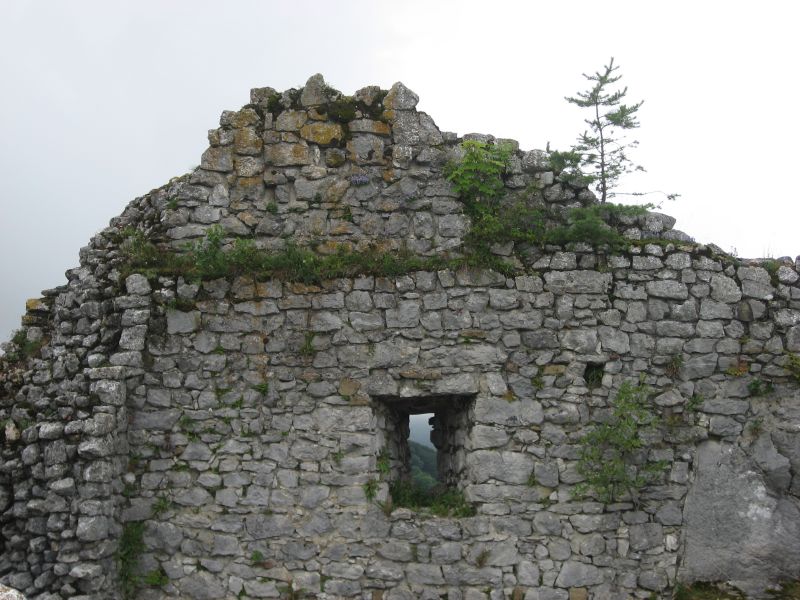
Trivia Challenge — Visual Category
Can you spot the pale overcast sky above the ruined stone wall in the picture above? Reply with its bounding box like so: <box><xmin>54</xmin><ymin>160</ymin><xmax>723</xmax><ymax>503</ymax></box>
<box><xmin>0</xmin><ymin>0</ymin><xmax>800</xmax><ymax>340</ymax></box>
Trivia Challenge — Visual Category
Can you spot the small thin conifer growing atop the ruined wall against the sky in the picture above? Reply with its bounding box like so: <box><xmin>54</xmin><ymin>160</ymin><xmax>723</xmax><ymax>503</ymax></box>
<box><xmin>559</xmin><ymin>57</ymin><xmax>644</xmax><ymax>202</ymax></box>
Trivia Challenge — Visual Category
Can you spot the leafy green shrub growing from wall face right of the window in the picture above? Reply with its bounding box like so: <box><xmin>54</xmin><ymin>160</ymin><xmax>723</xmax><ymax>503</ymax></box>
<box><xmin>574</xmin><ymin>381</ymin><xmax>666</xmax><ymax>504</ymax></box>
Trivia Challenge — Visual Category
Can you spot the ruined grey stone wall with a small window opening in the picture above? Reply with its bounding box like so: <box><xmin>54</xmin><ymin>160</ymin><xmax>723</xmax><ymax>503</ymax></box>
<box><xmin>0</xmin><ymin>75</ymin><xmax>800</xmax><ymax>600</ymax></box>
